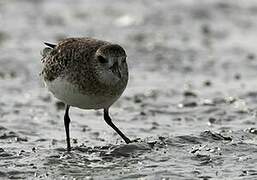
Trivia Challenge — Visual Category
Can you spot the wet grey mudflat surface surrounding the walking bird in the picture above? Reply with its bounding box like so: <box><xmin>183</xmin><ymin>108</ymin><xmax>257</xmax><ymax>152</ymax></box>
<box><xmin>0</xmin><ymin>0</ymin><xmax>257</xmax><ymax>180</ymax></box>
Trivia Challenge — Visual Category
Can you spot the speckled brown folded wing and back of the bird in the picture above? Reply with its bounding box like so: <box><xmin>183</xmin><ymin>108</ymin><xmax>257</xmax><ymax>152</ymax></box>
<box><xmin>42</xmin><ymin>38</ymin><xmax>108</xmax><ymax>81</ymax></box>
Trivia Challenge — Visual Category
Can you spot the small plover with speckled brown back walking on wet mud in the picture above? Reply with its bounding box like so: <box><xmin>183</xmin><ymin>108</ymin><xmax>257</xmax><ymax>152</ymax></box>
<box><xmin>41</xmin><ymin>38</ymin><xmax>131</xmax><ymax>151</ymax></box>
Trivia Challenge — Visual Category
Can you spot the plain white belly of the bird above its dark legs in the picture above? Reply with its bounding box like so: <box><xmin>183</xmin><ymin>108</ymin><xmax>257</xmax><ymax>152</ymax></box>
<box><xmin>45</xmin><ymin>78</ymin><xmax>119</xmax><ymax>109</ymax></box>
